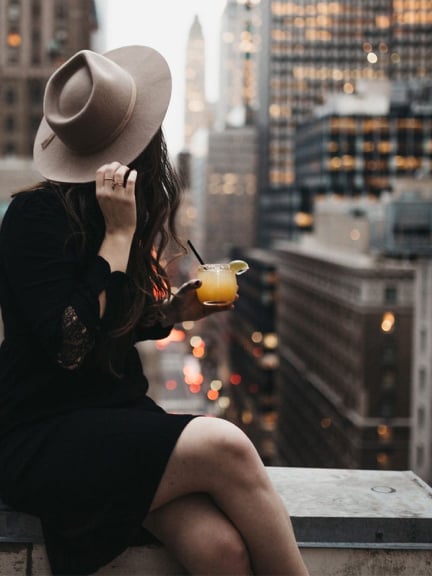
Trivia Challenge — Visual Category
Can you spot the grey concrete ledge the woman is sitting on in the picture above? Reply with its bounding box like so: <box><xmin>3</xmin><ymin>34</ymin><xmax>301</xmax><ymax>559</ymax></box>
<box><xmin>0</xmin><ymin>467</ymin><xmax>432</xmax><ymax>576</ymax></box>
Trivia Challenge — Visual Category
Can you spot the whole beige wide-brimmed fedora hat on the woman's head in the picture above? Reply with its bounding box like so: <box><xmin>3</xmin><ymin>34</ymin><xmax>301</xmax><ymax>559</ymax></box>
<box><xmin>33</xmin><ymin>46</ymin><xmax>171</xmax><ymax>182</ymax></box>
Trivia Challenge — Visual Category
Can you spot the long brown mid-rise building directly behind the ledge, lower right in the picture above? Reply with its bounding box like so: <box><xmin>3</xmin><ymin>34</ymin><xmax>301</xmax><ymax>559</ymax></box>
<box><xmin>276</xmin><ymin>244</ymin><xmax>414</xmax><ymax>470</ymax></box>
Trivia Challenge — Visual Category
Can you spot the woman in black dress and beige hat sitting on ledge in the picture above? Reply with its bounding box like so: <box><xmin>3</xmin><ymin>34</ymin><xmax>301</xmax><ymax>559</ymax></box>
<box><xmin>0</xmin><ymin>46</ymin><xmax>307</xmax><ymax>575</ymax></box>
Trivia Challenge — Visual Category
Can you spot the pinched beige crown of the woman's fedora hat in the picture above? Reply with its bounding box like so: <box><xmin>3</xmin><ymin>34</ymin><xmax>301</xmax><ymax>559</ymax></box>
<box><xmin>44</xmin><ymin>50</ymin><xmax>136</xmax><ymax>154</ymax></box>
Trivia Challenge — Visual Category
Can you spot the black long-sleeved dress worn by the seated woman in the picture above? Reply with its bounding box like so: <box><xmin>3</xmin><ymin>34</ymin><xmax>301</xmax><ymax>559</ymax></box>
<box><xmin>0</xmin><ymin>188</ymin><xmax>193</xmax><ymax>574</ymax></box>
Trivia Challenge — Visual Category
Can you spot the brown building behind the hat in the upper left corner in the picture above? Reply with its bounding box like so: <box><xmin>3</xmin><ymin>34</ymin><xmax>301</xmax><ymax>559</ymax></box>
<box><xmin>0</xmin><ymin>0</ymin><xmax>96</xmax><ymax>158</ymax></box>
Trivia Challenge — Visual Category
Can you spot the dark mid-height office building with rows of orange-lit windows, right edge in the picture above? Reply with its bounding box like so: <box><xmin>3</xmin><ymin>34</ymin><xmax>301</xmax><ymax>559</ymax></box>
<box><xmin>295</xmin><ymin>79</ymin><xmax>432</xmax><ymax>207</ymax></box>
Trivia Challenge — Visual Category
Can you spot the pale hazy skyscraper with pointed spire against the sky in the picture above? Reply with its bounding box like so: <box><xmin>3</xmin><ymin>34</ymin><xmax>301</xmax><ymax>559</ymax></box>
<box><xmin>184</xmin><ymin>15</ymin><xmax>208</xmax><ymax>148</ymax></box>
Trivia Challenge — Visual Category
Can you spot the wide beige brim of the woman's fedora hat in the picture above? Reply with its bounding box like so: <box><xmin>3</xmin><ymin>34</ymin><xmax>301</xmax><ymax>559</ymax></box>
<box><xmin>33</xmin><ymin>46</ymin><xmax>172</xmax><ymax>183</ymax></box>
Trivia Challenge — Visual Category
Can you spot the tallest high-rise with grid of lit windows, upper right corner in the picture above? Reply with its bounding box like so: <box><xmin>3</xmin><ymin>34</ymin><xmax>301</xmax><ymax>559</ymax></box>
<box><xmin>255</xmin><ymin>0</ymin><xmax>432</xmax><ymax>246</ymax></box>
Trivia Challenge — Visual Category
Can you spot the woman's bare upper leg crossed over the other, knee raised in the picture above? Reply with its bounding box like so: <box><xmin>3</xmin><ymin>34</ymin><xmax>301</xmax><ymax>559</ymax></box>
<box><xmin>152</xmin><ymin>417</ymin><xmax>308</xmax><ymax>576</ymax></box>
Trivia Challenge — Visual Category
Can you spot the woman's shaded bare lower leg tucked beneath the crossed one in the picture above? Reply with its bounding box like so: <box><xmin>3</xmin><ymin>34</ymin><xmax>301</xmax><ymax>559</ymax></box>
<box><xmin>144</xmin><ymin>494</ymin><xmax>252</xmax><ymax>576</ymax></box>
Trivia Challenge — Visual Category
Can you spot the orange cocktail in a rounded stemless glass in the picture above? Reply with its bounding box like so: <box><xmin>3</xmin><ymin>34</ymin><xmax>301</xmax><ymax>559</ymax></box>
<box><xmin>197</xmin><ymin>264</ymin><xmax>237</xmax><ymax>306</ymax></box>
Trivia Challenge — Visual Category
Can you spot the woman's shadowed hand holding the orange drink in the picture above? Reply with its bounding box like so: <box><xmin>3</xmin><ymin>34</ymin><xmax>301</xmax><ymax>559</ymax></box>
<box><xmin>162</xmin><ymin>280</ymin><xmax>234</xmax><ymax>326</ymax></box>
